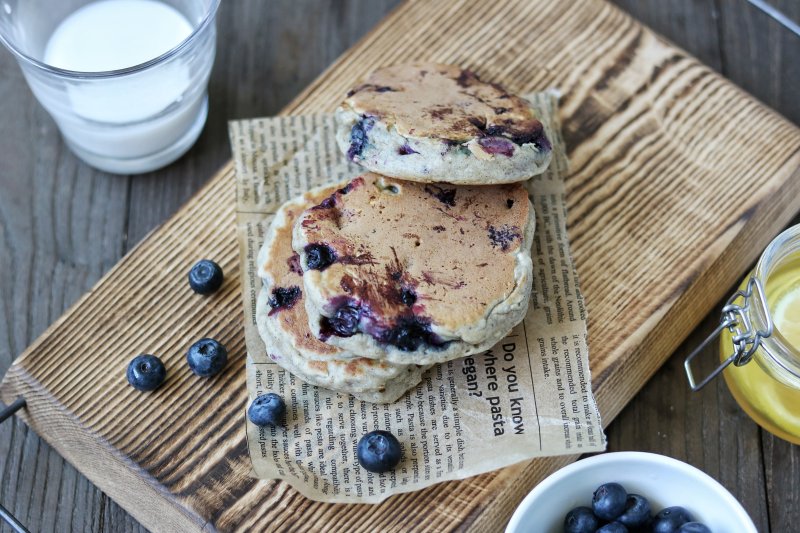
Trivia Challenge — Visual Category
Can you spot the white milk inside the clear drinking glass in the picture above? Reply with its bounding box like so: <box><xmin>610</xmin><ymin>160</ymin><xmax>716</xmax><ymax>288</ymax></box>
<box><xmin>32</xmin><ymin>0</ymin><xmax>213</xmax><ymax>173</ymax></box>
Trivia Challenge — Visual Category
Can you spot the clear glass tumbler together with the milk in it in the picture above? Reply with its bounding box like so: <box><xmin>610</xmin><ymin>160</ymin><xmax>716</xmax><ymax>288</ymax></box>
<box><xmin>0</xmin><ymin>0</ymin><xmax>219</xmax><ymax>174</ymax></box>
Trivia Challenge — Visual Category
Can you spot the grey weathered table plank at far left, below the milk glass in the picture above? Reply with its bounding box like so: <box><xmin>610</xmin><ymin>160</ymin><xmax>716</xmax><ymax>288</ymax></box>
<box><xmin>0</xmin><ymin>38</ymin><xmax>133</xmax><ymax>531</ymax></box>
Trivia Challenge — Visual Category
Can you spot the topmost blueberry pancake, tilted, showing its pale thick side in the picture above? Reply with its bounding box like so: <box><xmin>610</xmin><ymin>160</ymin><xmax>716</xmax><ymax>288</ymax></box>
<box><xmin>336</xmin><ymin>63</ymin><xmax>550</xmax><ymax>185</ymax></box>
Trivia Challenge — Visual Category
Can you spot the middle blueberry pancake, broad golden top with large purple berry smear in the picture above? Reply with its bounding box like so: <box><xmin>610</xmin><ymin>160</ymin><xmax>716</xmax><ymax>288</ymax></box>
<box><xmin>292</xmin><ymin>173</ymin><xmax>535</xmax><ymax>365</ymax></box>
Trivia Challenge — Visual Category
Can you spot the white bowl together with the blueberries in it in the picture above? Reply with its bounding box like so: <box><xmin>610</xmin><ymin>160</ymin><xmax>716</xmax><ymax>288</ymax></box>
<box><xmin>506</xmin><ymin>452</ymin><xmax>757</xmax><ymax>533</ymax></box>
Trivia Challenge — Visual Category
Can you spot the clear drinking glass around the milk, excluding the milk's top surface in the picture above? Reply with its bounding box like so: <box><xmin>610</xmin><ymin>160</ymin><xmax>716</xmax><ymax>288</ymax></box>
<box><xmin>0</xmin><ymin>0</ymin><xmax>220</xmax><ymax>174</ymax></box>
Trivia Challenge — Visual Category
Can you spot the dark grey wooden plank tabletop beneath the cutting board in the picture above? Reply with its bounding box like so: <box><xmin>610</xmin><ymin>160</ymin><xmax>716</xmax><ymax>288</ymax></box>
<box><xmin>0</xmin><ymin>0</ymin><xmax>800</xmax><ymax>532</ymax></box>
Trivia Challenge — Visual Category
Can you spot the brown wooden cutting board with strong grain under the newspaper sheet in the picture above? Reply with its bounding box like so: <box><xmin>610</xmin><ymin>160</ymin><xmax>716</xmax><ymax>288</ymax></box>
<box><xmin>0</xmin><ymin>0</ymin><xmax>800</xmax><ymax>531</ymax></box>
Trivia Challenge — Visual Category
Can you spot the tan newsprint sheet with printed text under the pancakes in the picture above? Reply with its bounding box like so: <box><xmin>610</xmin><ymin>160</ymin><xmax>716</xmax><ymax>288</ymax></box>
<box><xmin>229</xmin><ymin>93</ymin><xmax>605</xmax><ymax>503</ymax></box>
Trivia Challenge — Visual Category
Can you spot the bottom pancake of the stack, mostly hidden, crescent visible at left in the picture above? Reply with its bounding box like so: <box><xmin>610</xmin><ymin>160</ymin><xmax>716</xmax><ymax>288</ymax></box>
<box><xmin>256</xmin><ymin>187</ymin><xmax>427</xmax><ymax>403</ymax></box>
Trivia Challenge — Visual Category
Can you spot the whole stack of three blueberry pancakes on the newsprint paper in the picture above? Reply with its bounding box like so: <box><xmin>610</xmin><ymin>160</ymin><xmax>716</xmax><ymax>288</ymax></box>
<box><xmin>256</xmin><ymin>64</ymin><xmax>550</xmax><ymax>402</ymax></box>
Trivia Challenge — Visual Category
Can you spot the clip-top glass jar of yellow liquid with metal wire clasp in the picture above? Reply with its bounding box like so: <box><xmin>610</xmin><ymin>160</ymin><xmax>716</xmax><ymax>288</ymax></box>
<box><xmin>685</xmin><ymin>225</ymin><xmax>800</xmax><ymax>444</ymax></box>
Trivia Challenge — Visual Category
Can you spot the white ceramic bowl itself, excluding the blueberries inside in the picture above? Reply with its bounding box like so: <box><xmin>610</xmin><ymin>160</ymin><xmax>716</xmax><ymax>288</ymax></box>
<box><xmin>506</xmin><ymin>452</ymin><xmax>758</xmax><ymax>533</ymax></box>
